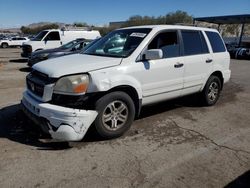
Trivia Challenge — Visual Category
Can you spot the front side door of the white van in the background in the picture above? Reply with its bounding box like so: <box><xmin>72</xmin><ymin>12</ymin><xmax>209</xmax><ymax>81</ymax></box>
<box><xmin>44</xmin><ymin>31</ymin><xmax>61</xmax><ymax>49</ymax></box>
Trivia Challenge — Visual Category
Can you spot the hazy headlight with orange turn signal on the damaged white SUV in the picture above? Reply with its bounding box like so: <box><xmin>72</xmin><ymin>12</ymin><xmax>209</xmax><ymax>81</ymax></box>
<box><xmin>54</xmin><ymin>74</ymin><xmax>89</xmax><ymax>95</ymax></box>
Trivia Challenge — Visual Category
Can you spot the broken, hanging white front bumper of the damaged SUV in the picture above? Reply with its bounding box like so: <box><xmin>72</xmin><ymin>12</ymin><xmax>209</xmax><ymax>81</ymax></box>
<box><xmin>21</xmin><ymin>91</ymin><xmax>97</xmax><ymax>141</ymax></box>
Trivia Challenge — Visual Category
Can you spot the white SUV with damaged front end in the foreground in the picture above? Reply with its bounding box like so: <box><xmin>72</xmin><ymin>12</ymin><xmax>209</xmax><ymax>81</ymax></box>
<box><xmin>22</xmin><ymin>25</ymin><xmax>231</xmax><ymax>141</ymax></box>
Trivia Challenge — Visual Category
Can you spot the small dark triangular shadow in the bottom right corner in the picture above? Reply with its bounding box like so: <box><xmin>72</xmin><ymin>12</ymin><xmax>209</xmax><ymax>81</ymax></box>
<box><xmin>224</xmin><ymin>170</ymin><xmax>250</xmax><ymax>188</ymax></box>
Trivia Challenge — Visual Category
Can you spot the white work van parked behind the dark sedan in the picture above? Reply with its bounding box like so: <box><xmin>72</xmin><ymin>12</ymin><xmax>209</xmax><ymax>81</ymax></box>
<box><xmin>21</xmin><ymin>29</ymin><xmax>101</xmax><ymax>58</ymax></box>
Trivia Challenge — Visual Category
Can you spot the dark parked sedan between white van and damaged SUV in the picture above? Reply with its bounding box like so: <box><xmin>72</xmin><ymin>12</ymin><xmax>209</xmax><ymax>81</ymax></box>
<box><xmin>28</xmin><ymin>39</ymin><xmax>91</xmax><ymax>67</ymax></box>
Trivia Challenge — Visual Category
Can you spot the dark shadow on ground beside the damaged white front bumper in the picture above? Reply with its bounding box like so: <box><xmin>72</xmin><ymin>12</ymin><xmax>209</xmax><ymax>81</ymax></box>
<box><xmin>0</xmin><ymin>104</ymin><xmax>70</xmax><ymax>150</ymax></box>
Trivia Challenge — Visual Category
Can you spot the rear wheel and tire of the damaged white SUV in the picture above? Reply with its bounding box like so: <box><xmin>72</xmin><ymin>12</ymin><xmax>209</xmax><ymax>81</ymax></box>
<box><xmin>201</xmin><ymin>75</ymin><xmax>222</xmax><ymax>106</ymax></box>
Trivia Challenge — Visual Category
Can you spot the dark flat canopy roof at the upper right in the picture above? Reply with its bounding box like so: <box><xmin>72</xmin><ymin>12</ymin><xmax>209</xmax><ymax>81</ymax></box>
<box><xmin>194</xmin><ymin>14</ymin><xmax>250</xmax><ymax>24</ymax></box>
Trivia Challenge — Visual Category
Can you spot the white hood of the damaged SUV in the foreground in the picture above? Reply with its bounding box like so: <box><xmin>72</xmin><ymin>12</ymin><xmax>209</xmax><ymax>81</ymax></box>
<box><xmin>32</xmin><ymin>54</ymin><xmax>122</xmax><ymax>78</ymax></box>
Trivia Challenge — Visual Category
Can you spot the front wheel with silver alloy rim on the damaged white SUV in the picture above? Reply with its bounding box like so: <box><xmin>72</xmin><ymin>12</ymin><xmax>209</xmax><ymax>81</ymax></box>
<box><xmin>94</xmin><ymin>91</ymin><xmax>135</xmax><ymax>139</ymax></box>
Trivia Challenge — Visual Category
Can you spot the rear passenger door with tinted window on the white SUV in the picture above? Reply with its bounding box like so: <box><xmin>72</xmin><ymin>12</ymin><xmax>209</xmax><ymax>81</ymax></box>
<box><xmin>181</xmin><ymin>30</ymin><xmax>213</xmax><ymax>95</ymax></box>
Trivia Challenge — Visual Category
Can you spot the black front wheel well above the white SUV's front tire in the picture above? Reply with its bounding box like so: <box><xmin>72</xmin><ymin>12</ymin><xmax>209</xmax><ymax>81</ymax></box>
<box><xmin>108</xmin><ymin>85</ymin><xmax>142</xmax><ymax>117</ymax></box>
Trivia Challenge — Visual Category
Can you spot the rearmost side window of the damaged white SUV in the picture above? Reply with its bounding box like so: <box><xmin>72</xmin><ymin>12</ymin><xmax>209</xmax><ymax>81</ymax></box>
<box><xmin>206</xmin><ymin>31</ymin><xmax>226</xmax><ymax>53</ymax></box>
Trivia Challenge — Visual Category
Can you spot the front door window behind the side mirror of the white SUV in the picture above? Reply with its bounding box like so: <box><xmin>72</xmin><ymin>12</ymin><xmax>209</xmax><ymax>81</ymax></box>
<box><xmin>148</xmin><ymin>31</ymin><xmax>180</xmax><ymax>58</ymax></box>
